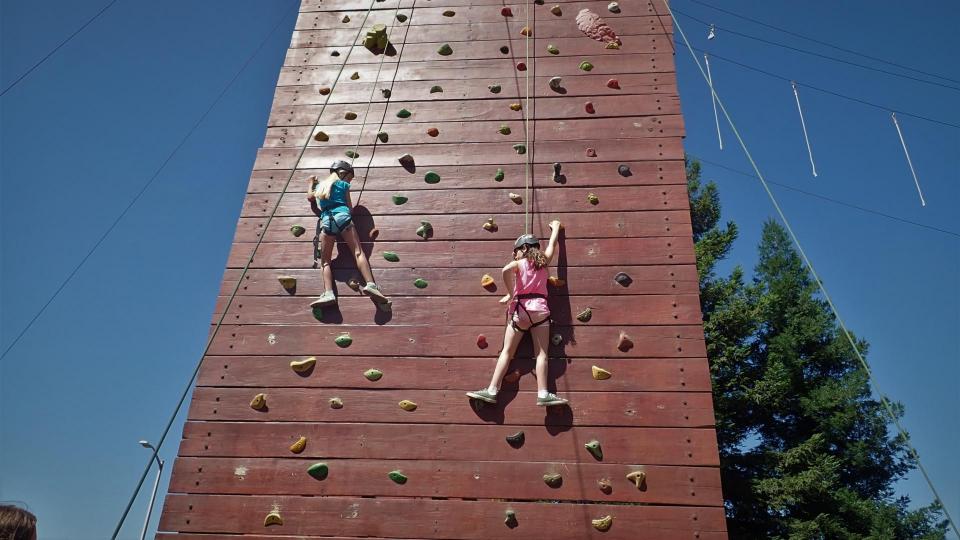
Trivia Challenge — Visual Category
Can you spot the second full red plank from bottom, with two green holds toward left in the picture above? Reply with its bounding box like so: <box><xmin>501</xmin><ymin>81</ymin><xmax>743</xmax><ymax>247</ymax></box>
<box><xmin>169</xmin><ymin>451</ymin><xmax>723</xmax><ymax>506</ymax></box>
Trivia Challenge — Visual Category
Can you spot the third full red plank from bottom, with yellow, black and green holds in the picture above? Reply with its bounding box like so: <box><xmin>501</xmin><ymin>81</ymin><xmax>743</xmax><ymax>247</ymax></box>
<box><xmin>180</xmin><ymin>421</ymin><xmax>719</xmax><ymax>467</ymax></box>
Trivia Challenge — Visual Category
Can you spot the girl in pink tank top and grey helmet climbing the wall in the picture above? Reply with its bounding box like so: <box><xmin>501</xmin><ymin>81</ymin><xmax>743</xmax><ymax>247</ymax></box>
<box><xmin>467</xmin><ymin>220</ymin><xmax>567</xmax><ymax>406</ymax></box>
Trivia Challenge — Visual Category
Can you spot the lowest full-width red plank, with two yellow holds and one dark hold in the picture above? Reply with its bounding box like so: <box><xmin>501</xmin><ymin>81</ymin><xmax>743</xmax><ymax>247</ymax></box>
<box><xmin>159</xmin><ymin>494</ymin><xmax>726</xmax><ymax>540</ymax></box>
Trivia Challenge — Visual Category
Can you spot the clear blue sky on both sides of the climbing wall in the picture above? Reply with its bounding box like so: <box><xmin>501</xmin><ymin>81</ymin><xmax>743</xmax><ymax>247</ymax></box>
<box><xmin>0</xmin><ymin>0</ymin><xmax>960</xmax><ymax>540</ymax></box>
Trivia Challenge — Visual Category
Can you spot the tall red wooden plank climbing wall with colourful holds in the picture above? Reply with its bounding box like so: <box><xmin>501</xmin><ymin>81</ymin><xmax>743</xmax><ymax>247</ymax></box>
<box><xmin>157</xmin><ymin>0</ymin><xmax>726</xmax><ymax>540</ymax></box>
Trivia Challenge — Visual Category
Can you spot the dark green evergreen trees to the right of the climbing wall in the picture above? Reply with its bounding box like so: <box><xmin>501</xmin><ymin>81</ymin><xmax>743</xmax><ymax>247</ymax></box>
<box><xmin>687</xmin><ymin>158</ymin><xmax>947</xmax><ymax>540</ymax></box>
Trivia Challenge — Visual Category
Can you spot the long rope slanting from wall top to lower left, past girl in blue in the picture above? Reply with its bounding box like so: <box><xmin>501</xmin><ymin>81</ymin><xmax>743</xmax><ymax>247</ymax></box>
<box><xmin>111</xmin><ymin>0</ymin><xmax>386</xmax><ymax>540</ymax></box>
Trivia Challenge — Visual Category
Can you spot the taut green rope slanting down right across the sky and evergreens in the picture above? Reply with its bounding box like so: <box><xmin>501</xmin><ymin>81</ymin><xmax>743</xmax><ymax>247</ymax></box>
<box><xmin>664</xmin><ymin>2</ymin><xmax>960</xmax><ymax>537</ymax></box>
